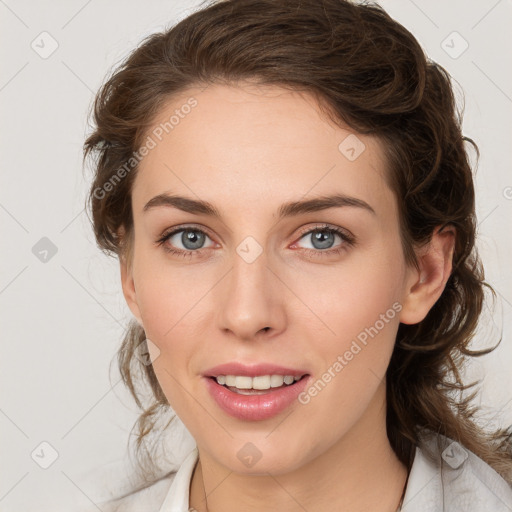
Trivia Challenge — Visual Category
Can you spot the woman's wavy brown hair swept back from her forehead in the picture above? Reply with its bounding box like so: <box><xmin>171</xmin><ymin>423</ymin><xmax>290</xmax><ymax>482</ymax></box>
<box><xmin>84</xmin><ymin>0</ymin><xmax>512</xmax><ymax>490</ymax></box>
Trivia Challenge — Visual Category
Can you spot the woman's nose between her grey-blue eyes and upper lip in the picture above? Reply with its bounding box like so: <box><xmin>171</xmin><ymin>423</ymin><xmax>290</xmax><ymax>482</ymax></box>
<box><xmin>216</xmin><ymin>247</ymin><xmax>286</xmax><ymax>341</ymax></box>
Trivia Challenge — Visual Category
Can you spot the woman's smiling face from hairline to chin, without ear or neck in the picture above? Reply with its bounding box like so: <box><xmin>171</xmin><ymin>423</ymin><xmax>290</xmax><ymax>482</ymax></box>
<box><xmin>122</xmin><ymin>84</ymin><xmax>417</xmax><ymax>474</ymax></box>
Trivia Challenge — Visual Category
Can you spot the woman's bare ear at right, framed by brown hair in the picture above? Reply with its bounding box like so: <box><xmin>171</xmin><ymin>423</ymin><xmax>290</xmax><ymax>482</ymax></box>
<box><xmin>400</xmin><ymin>225</ymin><xmax>456</xmax><ymax>324</ymax></box>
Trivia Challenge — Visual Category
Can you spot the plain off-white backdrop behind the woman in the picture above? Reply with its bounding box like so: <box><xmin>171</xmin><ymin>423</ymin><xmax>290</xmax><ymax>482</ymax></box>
<box><xmin>0</xmin><ymin>0</ymin><xmax>512</xmax><ymax>512</ymax></box>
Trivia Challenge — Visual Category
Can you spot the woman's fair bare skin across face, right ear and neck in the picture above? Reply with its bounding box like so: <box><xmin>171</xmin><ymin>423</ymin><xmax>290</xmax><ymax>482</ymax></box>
<box><xmin>121</xmin><ymin>82</ymin><xmax>455</xmax><ymax>512</ymax></box>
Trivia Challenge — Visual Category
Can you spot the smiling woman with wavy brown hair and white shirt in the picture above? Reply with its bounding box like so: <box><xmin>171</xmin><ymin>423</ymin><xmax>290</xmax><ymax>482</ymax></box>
<box><xmin>85</xmin><ymin>0</ymin><xmax>512</xmax><ymax>512</ymax></box>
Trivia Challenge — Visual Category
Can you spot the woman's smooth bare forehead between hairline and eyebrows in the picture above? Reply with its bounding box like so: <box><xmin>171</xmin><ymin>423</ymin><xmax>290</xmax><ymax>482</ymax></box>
<box><xmin>133</xmin><ymin>83</ymin><xmax>392</xmax><ymax>216</ymax></box>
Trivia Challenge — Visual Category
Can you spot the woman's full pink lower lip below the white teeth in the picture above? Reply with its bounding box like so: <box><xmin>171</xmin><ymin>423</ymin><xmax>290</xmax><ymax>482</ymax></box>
<box><xmin>204</xmin><ymin>375</ymin><xmax>310</xmax><ymax>421</ymax></box>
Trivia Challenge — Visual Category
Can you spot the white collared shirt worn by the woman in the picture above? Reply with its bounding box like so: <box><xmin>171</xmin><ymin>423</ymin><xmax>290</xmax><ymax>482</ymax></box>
<box><xmin>92</xmin><ymin>436</ymin><xmax>512</xmax><ymax>512</ymax></box>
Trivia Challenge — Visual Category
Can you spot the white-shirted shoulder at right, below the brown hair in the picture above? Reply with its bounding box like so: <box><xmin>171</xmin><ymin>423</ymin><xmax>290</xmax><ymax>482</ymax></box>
<box><xmin>403</xmin><ymin>435</ymin><xmax>512</xmax><ymax>512</ymax></box>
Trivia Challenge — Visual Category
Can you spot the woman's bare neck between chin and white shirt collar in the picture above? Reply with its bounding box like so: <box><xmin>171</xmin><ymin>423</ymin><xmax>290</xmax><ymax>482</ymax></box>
<box><xmin>189</xmin><ymin>387</ymin><xmax>407</xmax><ymax>512</ymax></box>
